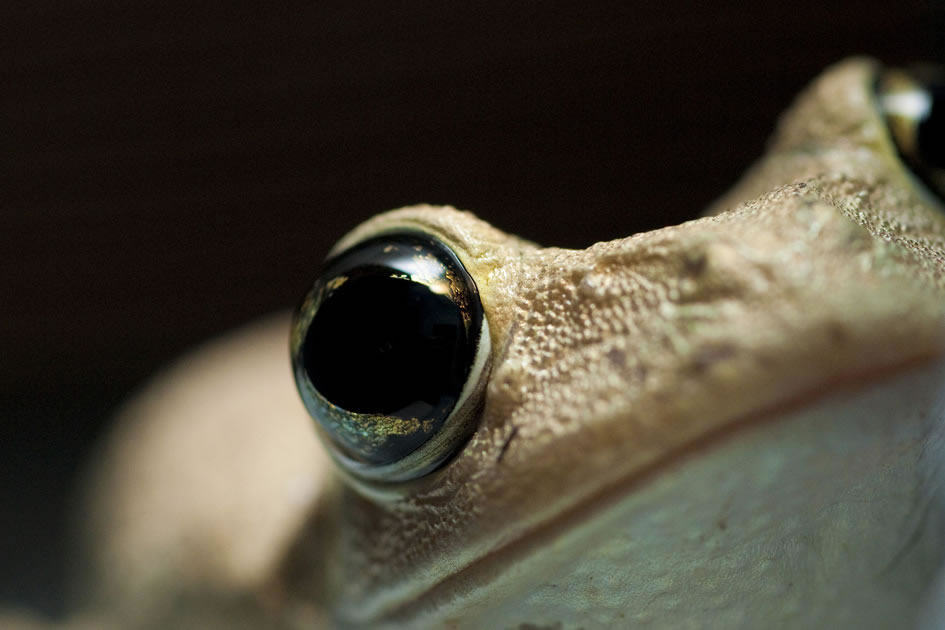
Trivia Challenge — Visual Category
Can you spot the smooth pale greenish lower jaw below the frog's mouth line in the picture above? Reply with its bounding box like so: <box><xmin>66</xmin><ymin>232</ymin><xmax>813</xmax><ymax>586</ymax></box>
<box><xmin>345</xmin><ymin>359</ymin><xmax>945</xmax><ymax>628</ymax></box>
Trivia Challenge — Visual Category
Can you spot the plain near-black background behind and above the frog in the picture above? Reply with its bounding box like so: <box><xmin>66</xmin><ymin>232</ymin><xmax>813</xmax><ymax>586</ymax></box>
<box><xmin>0</xmin><ymin>0</ymin><xmax>945</xmax><ymax>613</ymax></box>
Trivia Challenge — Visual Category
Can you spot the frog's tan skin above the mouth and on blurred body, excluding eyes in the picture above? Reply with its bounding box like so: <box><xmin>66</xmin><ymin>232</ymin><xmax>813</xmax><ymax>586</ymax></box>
<box><xmin>5</xmin><ymin>60</ymin><xmax>945</xmax><ymax>627</ymax></box>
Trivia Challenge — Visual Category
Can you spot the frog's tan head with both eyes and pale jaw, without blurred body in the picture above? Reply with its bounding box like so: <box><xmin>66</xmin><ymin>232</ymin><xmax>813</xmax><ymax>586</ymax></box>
<box><xmin>291</xmin><ymin>60</ymin><xmax>945</xmax><ymax>628</ymax></box>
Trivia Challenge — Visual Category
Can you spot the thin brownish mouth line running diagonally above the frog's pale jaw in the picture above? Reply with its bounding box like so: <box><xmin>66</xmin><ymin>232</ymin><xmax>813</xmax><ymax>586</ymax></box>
<box><xmin>357</xmin><ymin>350</ymin><xmax>945</xmax><ymax>623</ymax></box>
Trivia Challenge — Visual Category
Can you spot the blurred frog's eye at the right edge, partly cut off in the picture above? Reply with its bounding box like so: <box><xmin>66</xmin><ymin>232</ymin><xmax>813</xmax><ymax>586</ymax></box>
<box><xmin>877</xmin><ymin>68</ymin><xmax>945</xmax><ymax>197</ymax></box>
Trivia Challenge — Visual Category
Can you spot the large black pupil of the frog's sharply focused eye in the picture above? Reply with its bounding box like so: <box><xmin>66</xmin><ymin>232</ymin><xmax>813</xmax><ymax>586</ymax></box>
<box><xmin>302</xmin><ymin>268</ymin><xmax>469</xmax><ymax>418</ymax></box>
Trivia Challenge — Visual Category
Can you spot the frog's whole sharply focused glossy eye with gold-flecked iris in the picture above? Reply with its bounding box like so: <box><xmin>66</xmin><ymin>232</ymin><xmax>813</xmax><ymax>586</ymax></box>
<box><xmin>292</xmin><ymin>231</ymin><xmax>490</xmax><ymax>481</ymax></box>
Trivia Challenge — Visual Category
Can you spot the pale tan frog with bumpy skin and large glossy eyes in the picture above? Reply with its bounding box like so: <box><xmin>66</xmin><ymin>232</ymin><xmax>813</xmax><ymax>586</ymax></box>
<box><xmin>7</xmin><ymin>58</ymin><xmax>945</xmax><ymax>630</ymax></box>
